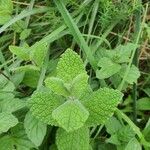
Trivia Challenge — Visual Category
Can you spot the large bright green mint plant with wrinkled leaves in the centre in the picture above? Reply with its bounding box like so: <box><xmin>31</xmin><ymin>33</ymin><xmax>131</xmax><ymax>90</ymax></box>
<box><xmin>28</xmin><ymin>49</ymin><xmax>123</xmax><ymax>150</ymax></box>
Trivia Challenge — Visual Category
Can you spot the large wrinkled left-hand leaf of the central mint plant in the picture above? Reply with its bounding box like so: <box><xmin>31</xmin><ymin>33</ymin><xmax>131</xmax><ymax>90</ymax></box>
<box><xmin>29</xmin><ymin>91</ymin><xmax>64</xmax><ymax>125</ymax></box>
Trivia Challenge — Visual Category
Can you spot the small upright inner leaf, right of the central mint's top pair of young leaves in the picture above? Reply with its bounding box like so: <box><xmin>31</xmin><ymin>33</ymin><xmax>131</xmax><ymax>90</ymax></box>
<box><xmin>70</xmin><ymin>73</ymin><xmax>88</xmax><ymax>99</ymax></box>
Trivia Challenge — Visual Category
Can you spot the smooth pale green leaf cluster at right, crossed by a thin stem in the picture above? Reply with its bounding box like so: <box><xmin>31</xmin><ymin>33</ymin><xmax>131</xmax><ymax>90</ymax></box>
<box><xmin>96</xmin><ymin>43</ymin><xmax>140</xmax><ymax>84</ymax></box>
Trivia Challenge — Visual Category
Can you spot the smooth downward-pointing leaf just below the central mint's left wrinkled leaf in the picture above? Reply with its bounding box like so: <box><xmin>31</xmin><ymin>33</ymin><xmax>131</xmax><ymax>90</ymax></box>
<box><xmin>24</xmin><ymin>112</ymin><xmax>47</xmax><ymax>146</ymax></box>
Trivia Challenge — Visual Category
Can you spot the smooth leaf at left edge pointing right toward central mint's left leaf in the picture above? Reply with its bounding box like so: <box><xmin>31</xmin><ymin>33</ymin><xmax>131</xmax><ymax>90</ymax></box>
<box><xmin>0</xmin><ymin>98</ymin><xmax>26</xmax><ymax>113</ymax></box>
